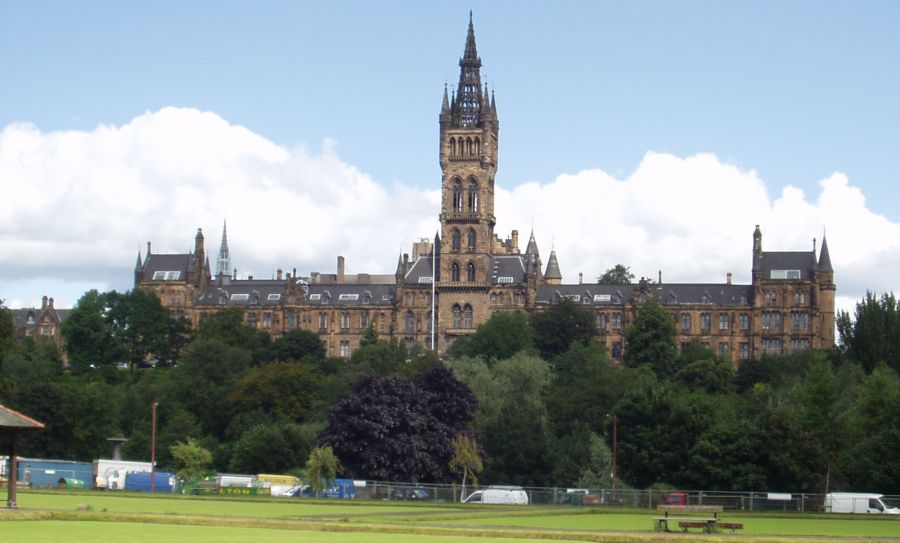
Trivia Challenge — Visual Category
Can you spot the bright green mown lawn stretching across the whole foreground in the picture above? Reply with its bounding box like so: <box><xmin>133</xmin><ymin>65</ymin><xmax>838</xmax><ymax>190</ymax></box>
<box><xmin>0</xmin><ymin>491</ymin><xmax>900</xmax><ymax>543</ymax></box>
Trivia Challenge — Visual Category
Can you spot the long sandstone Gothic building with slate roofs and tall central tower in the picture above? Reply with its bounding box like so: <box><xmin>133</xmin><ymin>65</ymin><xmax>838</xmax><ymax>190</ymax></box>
<box><xmin>134</xmin><ymin>19</ymin><xmax>835</xmax><ymax>365</ymax></box>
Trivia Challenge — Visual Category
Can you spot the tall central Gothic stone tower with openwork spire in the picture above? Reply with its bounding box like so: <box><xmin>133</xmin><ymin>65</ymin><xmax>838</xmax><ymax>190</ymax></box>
<box><xmin>439</xmin><ymin>13</ymin><xmax>499</xmax><ymax>335</ymax></box>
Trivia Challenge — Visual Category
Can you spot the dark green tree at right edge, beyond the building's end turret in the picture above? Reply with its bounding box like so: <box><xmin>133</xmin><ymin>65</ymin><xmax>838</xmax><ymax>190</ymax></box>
<box><xmin>837</xmin><ymin>292</ymin><xmax>900</xmax><ymax>372</ymax></box>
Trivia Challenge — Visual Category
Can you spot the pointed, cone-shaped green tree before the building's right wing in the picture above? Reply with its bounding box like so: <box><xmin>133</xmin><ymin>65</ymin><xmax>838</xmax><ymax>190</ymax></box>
<box><xmin>624</xmin><ymin>300</ymin><xmax>678</xmax><ymax>378</ymax></box>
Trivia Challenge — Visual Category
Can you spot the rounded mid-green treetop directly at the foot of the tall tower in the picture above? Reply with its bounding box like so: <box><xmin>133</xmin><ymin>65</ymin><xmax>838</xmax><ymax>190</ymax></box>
<box><xmin>449</xmin><ymin>313</ymin><xmax>534</xmax><ymax>364</ymax></box>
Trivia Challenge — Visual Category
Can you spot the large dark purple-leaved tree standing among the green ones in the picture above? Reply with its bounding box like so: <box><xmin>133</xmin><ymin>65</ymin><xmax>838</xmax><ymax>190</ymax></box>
<box><xmin>319</xmin><ymin>367</ymin><xmax>476</xmax><ymax>482</ymax></box>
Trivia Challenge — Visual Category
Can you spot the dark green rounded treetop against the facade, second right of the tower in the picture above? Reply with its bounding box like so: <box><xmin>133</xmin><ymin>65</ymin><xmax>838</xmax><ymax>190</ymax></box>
<box><xmin>531</xmin><ymin>300</ymin><xmax>597</xmax><ymax>360</ymax></box>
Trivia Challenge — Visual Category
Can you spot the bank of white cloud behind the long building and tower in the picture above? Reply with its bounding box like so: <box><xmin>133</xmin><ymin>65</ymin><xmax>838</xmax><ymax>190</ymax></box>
<box><xmin>0</xmin><ymin>108</ymin><xmax>900</xmax><ymax>318</ymax></box>
